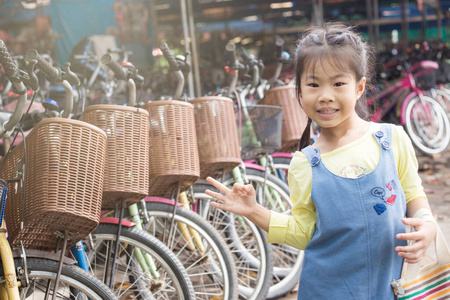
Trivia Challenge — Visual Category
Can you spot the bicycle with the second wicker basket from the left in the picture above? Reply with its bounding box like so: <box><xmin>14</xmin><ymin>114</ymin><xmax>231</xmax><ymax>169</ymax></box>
<box><xmin>78</xmin><ymin>54</ymin><xmax>195</xmax><ymax>299</ymax></box>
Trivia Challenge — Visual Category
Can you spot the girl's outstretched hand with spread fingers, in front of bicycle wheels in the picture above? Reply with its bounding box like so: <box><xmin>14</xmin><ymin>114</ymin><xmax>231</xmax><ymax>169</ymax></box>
<box><xmin>205</xmin><ymin>177</ymin><xmax>270</xmax><ymax>232</ymax></box>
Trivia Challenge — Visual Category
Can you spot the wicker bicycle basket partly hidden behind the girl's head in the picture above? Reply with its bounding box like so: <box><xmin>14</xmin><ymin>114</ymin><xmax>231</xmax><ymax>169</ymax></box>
<box><xmin>261</xmin><ymin>86</ymin><xmax>308</xmax><ymax>152</ymax></box>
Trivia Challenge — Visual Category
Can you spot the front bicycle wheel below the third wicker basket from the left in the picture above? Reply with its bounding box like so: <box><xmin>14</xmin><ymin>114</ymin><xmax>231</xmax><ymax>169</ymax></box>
<box><xmin>144</xmin><ymin>202</ymin><xmax>238</xmax><ymax>300</ymax></box>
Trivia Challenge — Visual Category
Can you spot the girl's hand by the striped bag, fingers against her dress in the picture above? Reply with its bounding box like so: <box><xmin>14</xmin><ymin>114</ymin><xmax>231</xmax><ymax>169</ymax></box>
<box><xmin>395</xmin><ymin>198</ymin><xmax>437</xmax><ymax>264</ymax></box>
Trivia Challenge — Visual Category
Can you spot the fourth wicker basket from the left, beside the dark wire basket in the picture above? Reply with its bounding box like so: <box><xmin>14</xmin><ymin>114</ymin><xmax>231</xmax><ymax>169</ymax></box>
<box><xmin>191</xmin><ymin>96</ymin><xmax>241</xmax><ymax>178</ymax></box>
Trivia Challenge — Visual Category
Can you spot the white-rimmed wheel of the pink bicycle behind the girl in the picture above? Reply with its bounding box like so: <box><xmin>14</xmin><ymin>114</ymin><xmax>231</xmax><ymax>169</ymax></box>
<box><xmin>405</xmin><ymin>96</ymin><xmax>450</xmax><ymax>155</ymax></box>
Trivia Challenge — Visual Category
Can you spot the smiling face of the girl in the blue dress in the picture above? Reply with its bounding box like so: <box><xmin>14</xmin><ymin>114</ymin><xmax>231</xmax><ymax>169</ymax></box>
<box><xmin>301</xmin><ymin>60</ymin><xmax>366</xmax><ymax>130</ymax></box>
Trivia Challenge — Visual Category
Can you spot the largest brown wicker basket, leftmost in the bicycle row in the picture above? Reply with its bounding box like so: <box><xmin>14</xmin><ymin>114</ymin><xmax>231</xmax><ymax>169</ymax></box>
<box><xmin>0</xmin><ymin>118</ymin><xmax>106</xmax><ymax>250</ymax></box>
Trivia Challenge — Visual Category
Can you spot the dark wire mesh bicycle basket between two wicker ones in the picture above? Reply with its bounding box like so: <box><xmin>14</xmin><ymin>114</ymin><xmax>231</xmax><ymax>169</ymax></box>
<box><xmin>236</xmin><ymin>104</ymin><xmax>283</xmax><ymax>160</ymax></box>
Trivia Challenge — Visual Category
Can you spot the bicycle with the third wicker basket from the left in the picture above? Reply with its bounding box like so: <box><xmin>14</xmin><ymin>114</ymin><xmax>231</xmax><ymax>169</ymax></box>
<box><xmin>130</xmin><ymin>44</ymin><xmax>237</xmax><ymax>300</ymax></box>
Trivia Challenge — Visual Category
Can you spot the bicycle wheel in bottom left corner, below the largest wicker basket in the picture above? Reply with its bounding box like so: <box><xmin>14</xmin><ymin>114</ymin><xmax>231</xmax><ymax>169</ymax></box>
<box><xmin>1</xmin><ymin>258</ymin><xmax>117</xmax><ymax>300</ymax></box>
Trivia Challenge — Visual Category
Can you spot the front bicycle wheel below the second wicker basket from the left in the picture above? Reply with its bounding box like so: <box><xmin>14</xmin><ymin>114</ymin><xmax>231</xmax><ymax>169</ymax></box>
<box><xmin>85</xmin><ymin>224</ymin><xmax>195</xmax><ymax>300</ymax></box>
